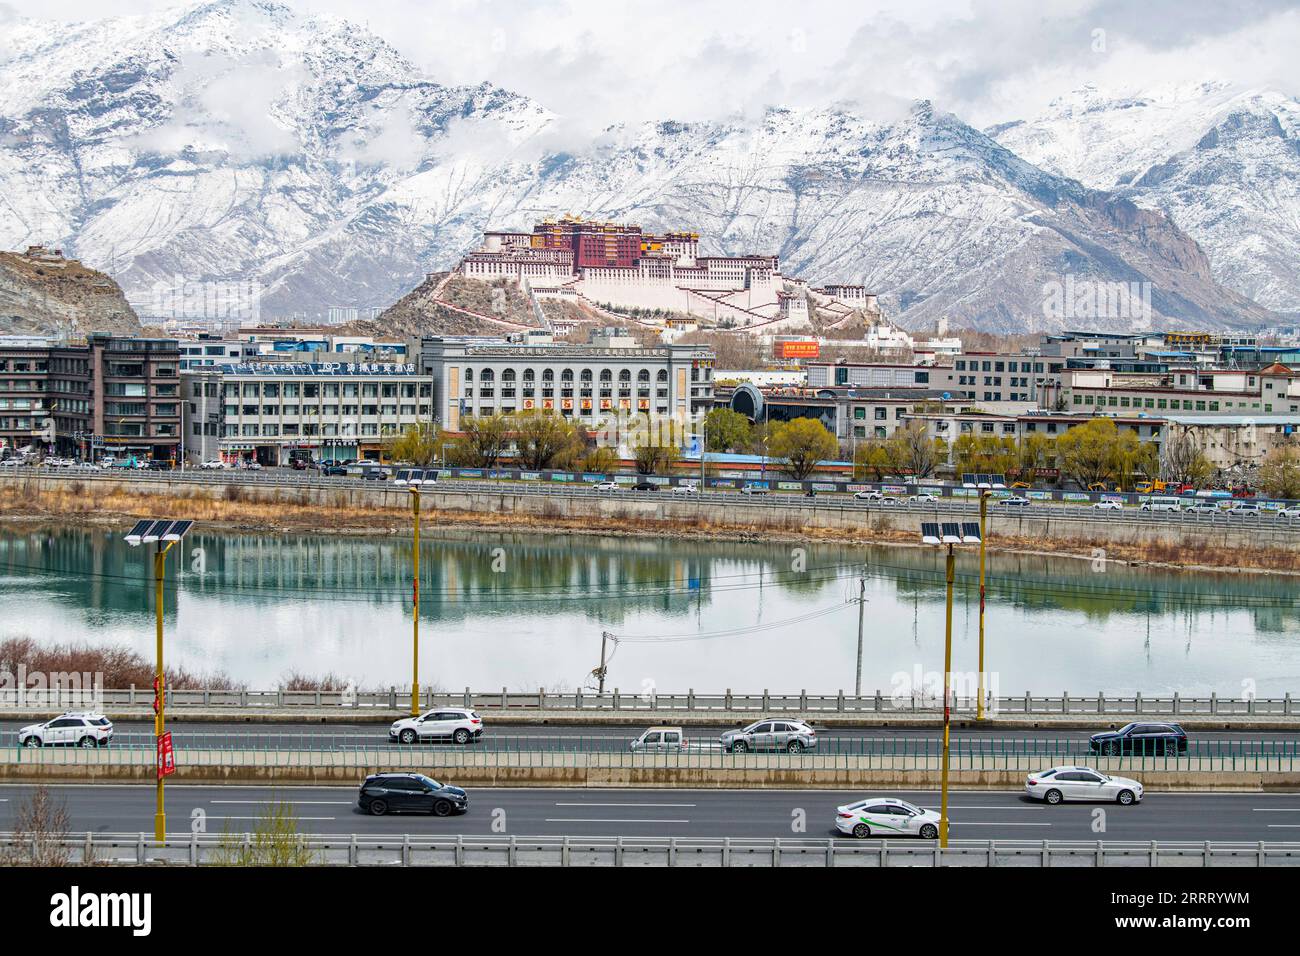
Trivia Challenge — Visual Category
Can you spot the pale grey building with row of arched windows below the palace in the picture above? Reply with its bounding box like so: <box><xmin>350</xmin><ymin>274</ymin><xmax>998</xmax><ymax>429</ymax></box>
<box><xmin>420</xmin><ymin>330</ymin><xmax>714</xmax><ymax>431</ymax></box>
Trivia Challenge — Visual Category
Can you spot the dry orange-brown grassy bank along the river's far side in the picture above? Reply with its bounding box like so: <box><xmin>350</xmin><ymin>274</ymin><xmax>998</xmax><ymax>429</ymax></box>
<box><xmin>0</xmin><ymin>480</ymin><xmax>1300</xmax><ymax>575</ymax></box>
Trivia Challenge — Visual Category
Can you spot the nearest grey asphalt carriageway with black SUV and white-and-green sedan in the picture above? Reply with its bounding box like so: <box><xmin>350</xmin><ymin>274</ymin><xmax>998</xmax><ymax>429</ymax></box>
<box><xmin>0</xmin><ymin>780</ymin><xmax>1300</xmax><ymax>843</ymax></box>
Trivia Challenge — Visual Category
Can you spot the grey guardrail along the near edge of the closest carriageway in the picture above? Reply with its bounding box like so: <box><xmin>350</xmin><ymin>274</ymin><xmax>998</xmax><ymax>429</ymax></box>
<box><xmin>0</xmin><ymin>832</ymin><xmax>1300</xmax><ymax>868</ymax></box>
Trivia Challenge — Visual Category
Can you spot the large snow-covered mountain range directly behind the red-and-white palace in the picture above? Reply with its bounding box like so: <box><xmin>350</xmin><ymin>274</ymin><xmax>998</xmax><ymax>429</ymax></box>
<box><xmin>0</xmin><ymin>0</ymin><xmax>1279</xmax><ymax>332</ymax></box>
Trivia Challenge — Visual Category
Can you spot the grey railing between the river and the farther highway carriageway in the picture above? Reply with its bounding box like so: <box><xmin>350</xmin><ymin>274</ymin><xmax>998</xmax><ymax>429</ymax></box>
<box><xmin>0</xmin><ymin>687</ymin><xmax>1300</xmax><ymax>719</ymax></box>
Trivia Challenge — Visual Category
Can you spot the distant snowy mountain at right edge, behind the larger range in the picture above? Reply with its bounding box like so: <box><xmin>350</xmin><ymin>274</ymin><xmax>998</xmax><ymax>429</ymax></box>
<box><xmin>989</xmin><ymin>82</ymin><xmax>1300</xmax><ymax>315</ymax></box>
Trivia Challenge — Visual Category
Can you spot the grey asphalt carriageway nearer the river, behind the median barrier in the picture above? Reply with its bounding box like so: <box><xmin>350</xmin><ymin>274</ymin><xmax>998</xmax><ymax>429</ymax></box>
<box><xmin>0</xmin><ymin>717</ymin><xmax>1300</xmax><ymax>756</ymax></box>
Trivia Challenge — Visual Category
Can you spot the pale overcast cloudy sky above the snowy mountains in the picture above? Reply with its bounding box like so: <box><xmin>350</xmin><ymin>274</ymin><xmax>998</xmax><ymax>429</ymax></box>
<box><xmin>0</xmin><ymin>0</ymin><xmax>1300</xmax><ymax>126</ymax></box>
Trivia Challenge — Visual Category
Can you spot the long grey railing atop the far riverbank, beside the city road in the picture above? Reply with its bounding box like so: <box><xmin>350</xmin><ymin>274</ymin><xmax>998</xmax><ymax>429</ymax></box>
<box><xmin>0</xmin><ymin>467</ymin><xmax>1300</xmax><ymax>531</ymax></box>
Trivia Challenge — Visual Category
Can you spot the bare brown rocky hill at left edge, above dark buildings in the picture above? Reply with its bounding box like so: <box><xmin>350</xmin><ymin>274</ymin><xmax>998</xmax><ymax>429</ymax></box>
<box><xmin>0</xmin><ymin>250</ymin><xmax>140</xmax><ymax>336</ymax></box>
